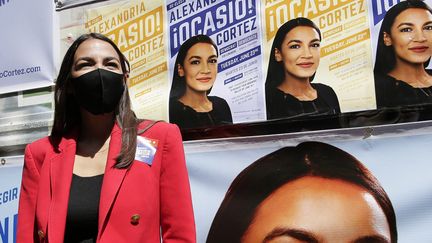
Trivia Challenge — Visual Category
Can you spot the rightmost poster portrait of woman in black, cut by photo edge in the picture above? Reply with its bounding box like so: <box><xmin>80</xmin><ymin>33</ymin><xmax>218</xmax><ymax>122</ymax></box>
<box><xmin>374</xmin><ymin>0</ymin><xmax>432</xmax><ymax>109</ymax></box>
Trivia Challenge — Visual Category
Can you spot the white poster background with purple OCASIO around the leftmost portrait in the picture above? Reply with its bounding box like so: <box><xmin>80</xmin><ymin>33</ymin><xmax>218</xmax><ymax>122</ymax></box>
<box><xmin>166</xmin><ymin>0</ymin><xmax>266</xmax><ymax>123</ymax></box>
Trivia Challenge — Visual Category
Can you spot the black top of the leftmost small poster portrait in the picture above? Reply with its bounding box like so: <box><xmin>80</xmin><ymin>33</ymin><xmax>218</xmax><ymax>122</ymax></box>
<box><xmin>169</xmin><ymin>96</ymin><xmax>232</xmax><ymax>129</ymax></box>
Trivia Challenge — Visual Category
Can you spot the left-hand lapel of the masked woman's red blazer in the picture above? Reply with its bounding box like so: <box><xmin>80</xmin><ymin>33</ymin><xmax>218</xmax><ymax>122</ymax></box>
<box><xmin>48</xmin><ymin>134</ymin><xmax>76</xmax><ymax>242</ymax></box>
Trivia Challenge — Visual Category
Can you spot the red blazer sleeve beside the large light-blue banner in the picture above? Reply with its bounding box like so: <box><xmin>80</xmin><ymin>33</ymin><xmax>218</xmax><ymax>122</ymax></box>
<box><xmin>160</xmin><ymin>124</ymin><xmax>196</xmax><ymax>243</ymax></box>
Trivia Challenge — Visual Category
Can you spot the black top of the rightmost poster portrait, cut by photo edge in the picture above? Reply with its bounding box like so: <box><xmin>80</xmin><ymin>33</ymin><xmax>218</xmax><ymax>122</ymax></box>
<box><xmin>375</xmin><ymin>70</ymin><xmax>432</xmax><ymax>109</ymax></box>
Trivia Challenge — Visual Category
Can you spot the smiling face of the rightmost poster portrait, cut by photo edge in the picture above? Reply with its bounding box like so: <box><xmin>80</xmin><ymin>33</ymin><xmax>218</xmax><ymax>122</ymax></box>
<box><xmin>384</xmin><ymin>8</ymin><xmax>432</xmax><ymax>65</ymax></box>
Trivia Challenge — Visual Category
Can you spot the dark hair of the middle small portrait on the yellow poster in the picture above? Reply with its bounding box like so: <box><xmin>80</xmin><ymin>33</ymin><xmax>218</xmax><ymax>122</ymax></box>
<box><xmin>265</xmin><ymin>18</ymin><xmax>321</xmax><ymax>90</ymax></box>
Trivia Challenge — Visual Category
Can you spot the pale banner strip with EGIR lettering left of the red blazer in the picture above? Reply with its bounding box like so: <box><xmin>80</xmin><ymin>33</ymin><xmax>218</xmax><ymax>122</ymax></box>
<box><xmin>0</xmin><ymin>156</ymin><xmax>23</xmax><ymax>243</ymax></box>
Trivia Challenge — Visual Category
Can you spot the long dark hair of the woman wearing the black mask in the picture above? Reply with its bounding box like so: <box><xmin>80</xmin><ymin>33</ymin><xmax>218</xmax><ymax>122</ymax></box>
<box><xmin>50</xmin><ymin>33</ymin><xmax>140</xmax><ymax>168</ymax></box>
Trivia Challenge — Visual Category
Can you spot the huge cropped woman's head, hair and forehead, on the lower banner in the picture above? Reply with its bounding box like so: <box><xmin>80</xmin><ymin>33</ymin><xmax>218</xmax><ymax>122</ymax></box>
<box><xmin>206</xmin><ymin>142</ymin><xmax>397</xmax><ymax>243</ymax></box>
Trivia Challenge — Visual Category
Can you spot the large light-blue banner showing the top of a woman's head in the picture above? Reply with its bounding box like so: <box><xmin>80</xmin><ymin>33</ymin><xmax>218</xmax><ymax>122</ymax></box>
<box><xmin>185</xmin><ymin>122</ymin><xmax>432</xmax><ymax>243</ymax></box>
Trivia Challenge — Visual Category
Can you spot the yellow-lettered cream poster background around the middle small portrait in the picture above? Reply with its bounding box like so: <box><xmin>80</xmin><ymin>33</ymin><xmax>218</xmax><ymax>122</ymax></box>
<box><xmin>262</xmin><ymin>0</ymin><xmax>376</xmax><ymax>112</ymax></box>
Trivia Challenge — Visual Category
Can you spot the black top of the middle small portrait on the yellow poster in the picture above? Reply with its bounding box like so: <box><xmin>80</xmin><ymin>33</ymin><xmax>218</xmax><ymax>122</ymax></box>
<box><xmin>266</xmin><ymin>83</ymin><xmax>340</xmax><ymax>120</ymax></box>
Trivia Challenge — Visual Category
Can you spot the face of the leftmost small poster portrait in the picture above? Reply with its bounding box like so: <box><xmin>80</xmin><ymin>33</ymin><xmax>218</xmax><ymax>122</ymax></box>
<box><xmin>177</xmin><ymin>43</ymin><xmax>217</xmax><ymax>94</ymax></box>
